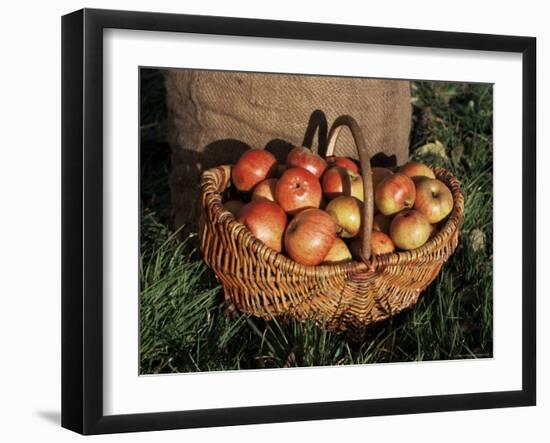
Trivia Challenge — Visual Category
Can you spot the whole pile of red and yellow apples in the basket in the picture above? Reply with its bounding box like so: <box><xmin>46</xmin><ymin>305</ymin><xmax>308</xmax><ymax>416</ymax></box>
<box><xmin>224</xmin><ymin>147</ymin><xmax>453</xmax><ymax>265</ymax></box>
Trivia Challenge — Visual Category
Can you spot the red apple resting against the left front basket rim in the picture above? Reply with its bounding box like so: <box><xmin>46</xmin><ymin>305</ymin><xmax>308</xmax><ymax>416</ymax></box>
<box><xmin>237</xmin><ymin>200</ymin><xmax>287</xmax><ymax>252</ymax></box>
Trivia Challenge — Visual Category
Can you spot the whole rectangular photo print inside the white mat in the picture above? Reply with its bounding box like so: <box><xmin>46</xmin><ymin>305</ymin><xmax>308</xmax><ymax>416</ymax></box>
<box><xmin>139</xmin><ymin>67</ymin><xmax>493</xmax><ymax>375</ymax></box>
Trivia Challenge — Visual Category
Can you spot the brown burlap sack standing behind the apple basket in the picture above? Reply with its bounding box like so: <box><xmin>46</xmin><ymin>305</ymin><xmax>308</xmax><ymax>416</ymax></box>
<box><xmin>165</xmin><ymin>69</ymin><xmax>411</xmax><ymax>227</ymax></box>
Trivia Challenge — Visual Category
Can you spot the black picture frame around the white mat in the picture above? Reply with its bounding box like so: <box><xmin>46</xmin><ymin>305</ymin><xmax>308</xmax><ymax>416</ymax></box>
<box><xmin>62</xmin><ymin>9</ymin><xmax>536</xmax><ymax>434</ymax></box>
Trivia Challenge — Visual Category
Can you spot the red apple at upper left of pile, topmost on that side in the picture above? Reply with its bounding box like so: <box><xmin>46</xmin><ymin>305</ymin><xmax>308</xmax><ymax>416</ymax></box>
<box><xmin>231</xmin><ymin>149</ymin><xmax>277</xmax><ymax>192</ymax></box>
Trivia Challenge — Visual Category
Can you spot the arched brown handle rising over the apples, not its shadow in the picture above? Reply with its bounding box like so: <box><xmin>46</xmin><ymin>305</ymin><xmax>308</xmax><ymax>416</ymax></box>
<box><xmin>326</xmin><ymin>115</ymin><xmax>374</xmax><ymax>265</ymax></box>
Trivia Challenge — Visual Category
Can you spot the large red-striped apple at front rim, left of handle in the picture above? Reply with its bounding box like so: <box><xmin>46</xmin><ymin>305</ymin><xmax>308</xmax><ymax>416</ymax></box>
<box><xmin>284</xmin><ymin>208</ymin><xmax>336</xmax><ymax>266</ymax></box>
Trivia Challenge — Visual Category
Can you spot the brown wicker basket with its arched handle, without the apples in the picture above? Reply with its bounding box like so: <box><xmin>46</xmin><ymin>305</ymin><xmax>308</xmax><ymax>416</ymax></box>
<box><xmin>200</xmin><ymin>116</ymin><xmax>464</xmax><ymax>330</ymax></box>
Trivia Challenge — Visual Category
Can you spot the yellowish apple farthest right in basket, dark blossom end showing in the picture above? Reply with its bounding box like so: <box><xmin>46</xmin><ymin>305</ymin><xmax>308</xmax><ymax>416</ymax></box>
<box><xmin>414</xmin><ymin>178</ymin><xmax>454</xmax><ymax>223</ymax></box>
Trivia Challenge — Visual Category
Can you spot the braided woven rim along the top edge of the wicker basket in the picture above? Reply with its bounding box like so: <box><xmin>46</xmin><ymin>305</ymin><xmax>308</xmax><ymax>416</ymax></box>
<box><xmin>201</xmin><ymin>165</ymin><xmax>464</xmax><ymax>275</ymax></box>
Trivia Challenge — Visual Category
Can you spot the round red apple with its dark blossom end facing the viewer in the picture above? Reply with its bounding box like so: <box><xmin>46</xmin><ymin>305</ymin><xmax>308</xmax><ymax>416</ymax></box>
<box><xmin>275</xmin><ymin>168</ymin><xmax>323</xmax><ymax>215</ymax></box>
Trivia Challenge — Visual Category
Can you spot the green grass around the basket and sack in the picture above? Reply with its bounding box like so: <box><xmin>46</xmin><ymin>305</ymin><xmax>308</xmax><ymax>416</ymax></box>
<box><xmin>140</xmin><ymin>71</ymin><xmax>493</xmax><ymax>374</ymax></box>
